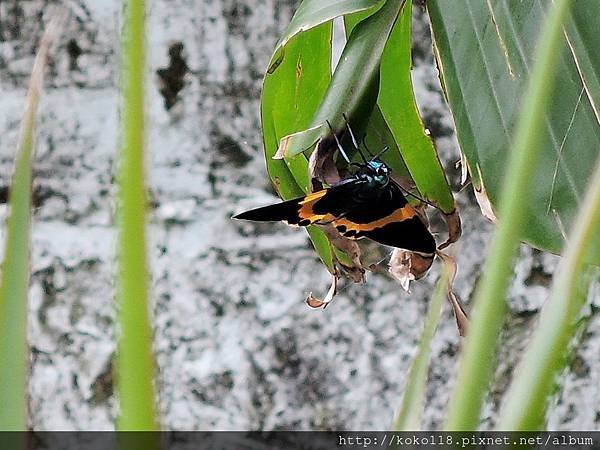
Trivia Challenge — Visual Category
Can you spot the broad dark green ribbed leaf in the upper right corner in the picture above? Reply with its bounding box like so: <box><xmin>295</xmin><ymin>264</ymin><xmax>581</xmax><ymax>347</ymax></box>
<box><xmin>427</xmin><ymin>0</ymin><xmax>600</xmax><ymax>263</ymax></box>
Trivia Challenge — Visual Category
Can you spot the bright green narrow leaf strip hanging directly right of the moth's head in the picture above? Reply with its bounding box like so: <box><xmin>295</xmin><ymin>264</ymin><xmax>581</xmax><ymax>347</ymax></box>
<box><xmin>377</xmin><ymin>0</ymin><xmax>455</xmax><ymax>214</ymax></box>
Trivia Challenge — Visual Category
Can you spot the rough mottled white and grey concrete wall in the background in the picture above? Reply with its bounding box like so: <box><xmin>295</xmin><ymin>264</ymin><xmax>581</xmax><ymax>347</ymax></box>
<box><xmin>0</xmin><ymin>0</ymin><xmax>600</xmax><ymax>430</ymax></box>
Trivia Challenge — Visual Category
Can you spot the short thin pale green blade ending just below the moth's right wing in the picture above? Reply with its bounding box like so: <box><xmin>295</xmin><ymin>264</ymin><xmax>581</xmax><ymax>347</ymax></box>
<box><xmin>394</xmin><ymin>264</ymin><xmax>449</xmax><ymax>431</ymax></box>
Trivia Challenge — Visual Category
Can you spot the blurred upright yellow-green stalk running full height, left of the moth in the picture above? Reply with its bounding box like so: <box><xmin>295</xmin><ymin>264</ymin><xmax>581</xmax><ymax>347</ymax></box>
<box><xmin>117</xmin><ymin>0</ymin><xmax>158</xmax><ymax>430</ymax></box>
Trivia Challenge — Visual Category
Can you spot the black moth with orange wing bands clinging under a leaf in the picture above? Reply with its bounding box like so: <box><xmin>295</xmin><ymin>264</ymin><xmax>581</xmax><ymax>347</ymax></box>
<box><xmin>233</xmin><ymin>122</ymin><xmax>436</xmax><ymax>256</ymax></box>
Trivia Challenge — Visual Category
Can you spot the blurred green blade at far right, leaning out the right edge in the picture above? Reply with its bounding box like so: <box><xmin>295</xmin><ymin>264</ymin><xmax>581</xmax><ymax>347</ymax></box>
<box><xmin>498</xmin><ymin>159</ymin><xmax>600</xmax><ymax>431</ymax></box>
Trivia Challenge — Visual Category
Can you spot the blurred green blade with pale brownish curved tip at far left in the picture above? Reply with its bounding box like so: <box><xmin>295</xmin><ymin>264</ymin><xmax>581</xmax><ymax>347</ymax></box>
<box><xmin>0</xmin><ymin>14</ymin><xmax>64</xmax><ymax>431</ymax></box>
